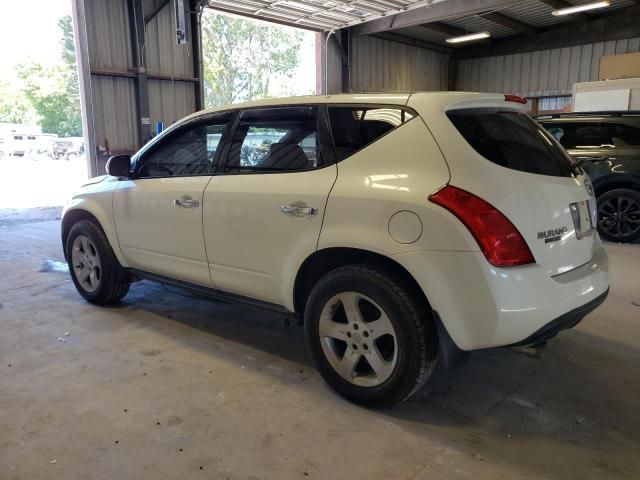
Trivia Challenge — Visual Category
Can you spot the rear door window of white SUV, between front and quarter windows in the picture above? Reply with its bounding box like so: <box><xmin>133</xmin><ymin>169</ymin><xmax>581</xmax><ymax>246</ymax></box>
<box><xmin>225</xmin><ymin>106</ymin><xmax>323</xmax><ymax>172</ymax></box>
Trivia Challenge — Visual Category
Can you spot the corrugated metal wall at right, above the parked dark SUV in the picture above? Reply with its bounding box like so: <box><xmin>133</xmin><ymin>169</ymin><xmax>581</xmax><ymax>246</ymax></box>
<box><xmin>456</xmin><ymin>38</ymin><xmax>640</xmax><ymax>97</ymax></box>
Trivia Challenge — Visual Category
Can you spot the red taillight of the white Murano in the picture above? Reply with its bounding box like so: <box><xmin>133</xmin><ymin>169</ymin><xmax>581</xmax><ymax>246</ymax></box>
<box><xmin>429</xmin><ymin>185</ymin><xmax>535</xmax><ymax>267</ymax></box>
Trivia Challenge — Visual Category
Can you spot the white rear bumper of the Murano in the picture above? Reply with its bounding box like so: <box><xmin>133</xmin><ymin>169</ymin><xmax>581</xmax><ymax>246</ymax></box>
<box><xmin>393</xmin><ymin>242</ymin><xmax>609</xmax><ymax>351</ymax></box>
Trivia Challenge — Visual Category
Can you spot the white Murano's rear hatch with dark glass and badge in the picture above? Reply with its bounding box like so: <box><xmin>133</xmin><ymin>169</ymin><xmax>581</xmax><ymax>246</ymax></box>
<box><xmin>409</xmin><ymin>94</ymin><xmax>596</xmax><ymax>275</ymax></box>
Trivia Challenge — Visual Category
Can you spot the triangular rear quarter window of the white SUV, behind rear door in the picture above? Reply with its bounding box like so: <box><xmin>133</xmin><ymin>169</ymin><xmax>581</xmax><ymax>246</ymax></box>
<box><xmin>329</xmin><ymin>107</ymin><xmax>414</xmax><ymax>160</ymax></box>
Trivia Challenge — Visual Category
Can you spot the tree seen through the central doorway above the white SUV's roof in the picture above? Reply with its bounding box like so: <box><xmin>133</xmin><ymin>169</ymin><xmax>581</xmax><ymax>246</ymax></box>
<box><xmin>202</xmin><ymin>13</ymin><xmax>302</xmax><ymax>107</ymax></box>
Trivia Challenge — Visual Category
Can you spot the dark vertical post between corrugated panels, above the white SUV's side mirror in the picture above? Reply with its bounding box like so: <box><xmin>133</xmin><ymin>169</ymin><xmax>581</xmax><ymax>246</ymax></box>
<box><xmin>127</xmin><ymin>0</ymin><xmax>151</xmax><ymax>148</ymax></box>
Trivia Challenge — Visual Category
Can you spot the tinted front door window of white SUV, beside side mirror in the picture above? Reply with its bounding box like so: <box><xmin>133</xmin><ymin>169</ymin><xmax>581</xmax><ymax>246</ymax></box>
<box><xmin>138</xmin><ymin>114</ymin><xmax>230</xmax><ymax>178</ymax></box>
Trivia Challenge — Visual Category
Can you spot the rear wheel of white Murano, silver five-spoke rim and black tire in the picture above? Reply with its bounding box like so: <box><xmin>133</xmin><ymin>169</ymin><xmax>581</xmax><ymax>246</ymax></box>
<box><xmin>304</xmin><ymin>265</ymin><xmax>438</xmax><ymax>408</ymax></box>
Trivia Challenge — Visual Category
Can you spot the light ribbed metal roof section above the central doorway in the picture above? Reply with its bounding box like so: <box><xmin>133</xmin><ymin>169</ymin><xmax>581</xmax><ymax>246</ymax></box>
<box><xmin>208</xmin><ymin>0</ymin><xmax>445</xmax><ymax>30</ymax></box>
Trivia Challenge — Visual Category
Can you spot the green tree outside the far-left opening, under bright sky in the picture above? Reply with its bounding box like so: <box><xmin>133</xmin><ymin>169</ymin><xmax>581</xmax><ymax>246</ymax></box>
<box><xmin>17</xmin><ymin>15</ymin><xmax>82</xmax><ymax>137</ymax></box>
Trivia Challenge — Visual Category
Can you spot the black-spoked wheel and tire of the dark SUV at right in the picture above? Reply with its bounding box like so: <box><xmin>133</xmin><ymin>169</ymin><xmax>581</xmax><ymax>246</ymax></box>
<box><xmin>598</xmin><ymin>188</ymin><xmax>640</xmax><ymax>243</ymax></box>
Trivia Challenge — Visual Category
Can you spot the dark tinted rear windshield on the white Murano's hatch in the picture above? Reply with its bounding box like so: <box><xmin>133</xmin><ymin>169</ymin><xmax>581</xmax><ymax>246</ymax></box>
<box><xmin>447</xmin><ymin>108</ymin><xmax>572</xmax><ymax>177</ymax></box>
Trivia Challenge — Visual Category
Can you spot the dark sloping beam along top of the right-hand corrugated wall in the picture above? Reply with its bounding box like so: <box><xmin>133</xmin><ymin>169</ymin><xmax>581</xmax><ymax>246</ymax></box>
<box><xmin>455</xmin><ymin>6</ymin><xmax>640</xmax><ymax>60</ymax></box>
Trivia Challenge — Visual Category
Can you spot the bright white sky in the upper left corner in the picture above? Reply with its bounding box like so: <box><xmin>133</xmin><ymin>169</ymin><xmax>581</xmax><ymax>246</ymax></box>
<box><xmin>0</xmin><ymin>0</ymin><xmax>71</xmax><ymax>80</ymax></box>
